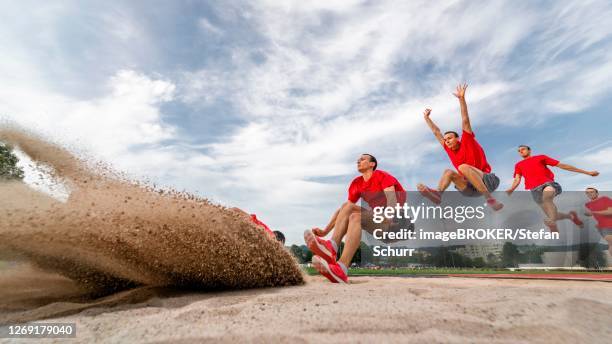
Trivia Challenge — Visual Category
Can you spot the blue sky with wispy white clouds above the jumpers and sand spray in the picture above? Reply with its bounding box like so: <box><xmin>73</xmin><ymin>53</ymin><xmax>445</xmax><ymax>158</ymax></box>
<box><xmin>0</xmin><ymin>0</ymin><xmax>612</xmax><ymax>243</ymax></box>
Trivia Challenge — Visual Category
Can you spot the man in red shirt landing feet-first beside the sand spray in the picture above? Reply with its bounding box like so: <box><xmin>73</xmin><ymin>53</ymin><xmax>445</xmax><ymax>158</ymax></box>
<box><xmin>304</xmin><ymin>154</ymin><xmax>406</xmax><ymax>283</ymax></box>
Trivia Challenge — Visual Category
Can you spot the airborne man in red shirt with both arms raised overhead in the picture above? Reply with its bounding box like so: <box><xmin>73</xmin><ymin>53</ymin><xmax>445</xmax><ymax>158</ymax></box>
<box><xmin>417</xmin><ymin>84</ymin><xmax>504</xmax><ymax>210</ymax></box>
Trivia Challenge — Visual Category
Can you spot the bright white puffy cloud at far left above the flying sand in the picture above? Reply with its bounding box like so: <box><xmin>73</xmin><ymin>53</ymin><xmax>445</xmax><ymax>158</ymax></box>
<box><xmin>0</xmin><ymin>70</ymin><xmax>175</xmax><ymax>159</ymax></box>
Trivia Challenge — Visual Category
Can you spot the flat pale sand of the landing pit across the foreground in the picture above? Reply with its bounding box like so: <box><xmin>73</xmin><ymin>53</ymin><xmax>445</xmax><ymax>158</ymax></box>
<box><xmin>2</xmin><ymin>277</ymin><xmax>612</xmax><ymax>343</ymax></box>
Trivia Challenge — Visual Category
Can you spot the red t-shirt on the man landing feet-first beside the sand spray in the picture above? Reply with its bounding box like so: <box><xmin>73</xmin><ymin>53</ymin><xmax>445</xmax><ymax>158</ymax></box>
<box><xmin>348</xmin><ymin>170</ymin><xmax>406</xmax><ymax>208</ymax></box>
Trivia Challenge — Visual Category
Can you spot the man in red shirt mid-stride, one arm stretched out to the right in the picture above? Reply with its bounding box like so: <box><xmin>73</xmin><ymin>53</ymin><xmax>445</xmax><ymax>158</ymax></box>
<box><xmin>506</xmin><ymin>145</ymin><xmax>599</xmax><ymax>232</ymax></box>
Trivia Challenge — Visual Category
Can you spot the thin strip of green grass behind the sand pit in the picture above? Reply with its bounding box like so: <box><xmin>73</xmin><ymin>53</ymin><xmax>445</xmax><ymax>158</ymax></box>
<box><xmin>304</xmin><ymin>268</ymin><xmax>610</xmax><ymax>276</ymax></box>
